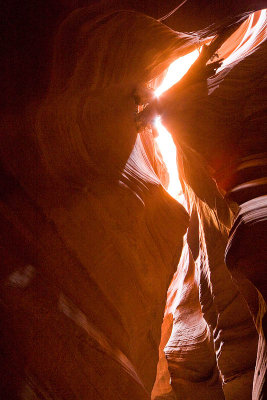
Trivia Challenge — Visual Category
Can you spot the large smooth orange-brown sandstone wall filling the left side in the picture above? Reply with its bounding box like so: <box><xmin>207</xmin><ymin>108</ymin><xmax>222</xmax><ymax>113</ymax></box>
<box><xmin>1</xmin><ymin>10</ymin><xmax>193</xmax><ymax>400</ymax></box>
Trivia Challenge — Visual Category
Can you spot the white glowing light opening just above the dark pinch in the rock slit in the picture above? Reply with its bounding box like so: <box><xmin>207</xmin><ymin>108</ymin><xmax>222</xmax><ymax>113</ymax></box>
<box><xmin>155</xmin><ymin>50</ymin><xmax>200</xmax><ymax>97</ymax></box>
